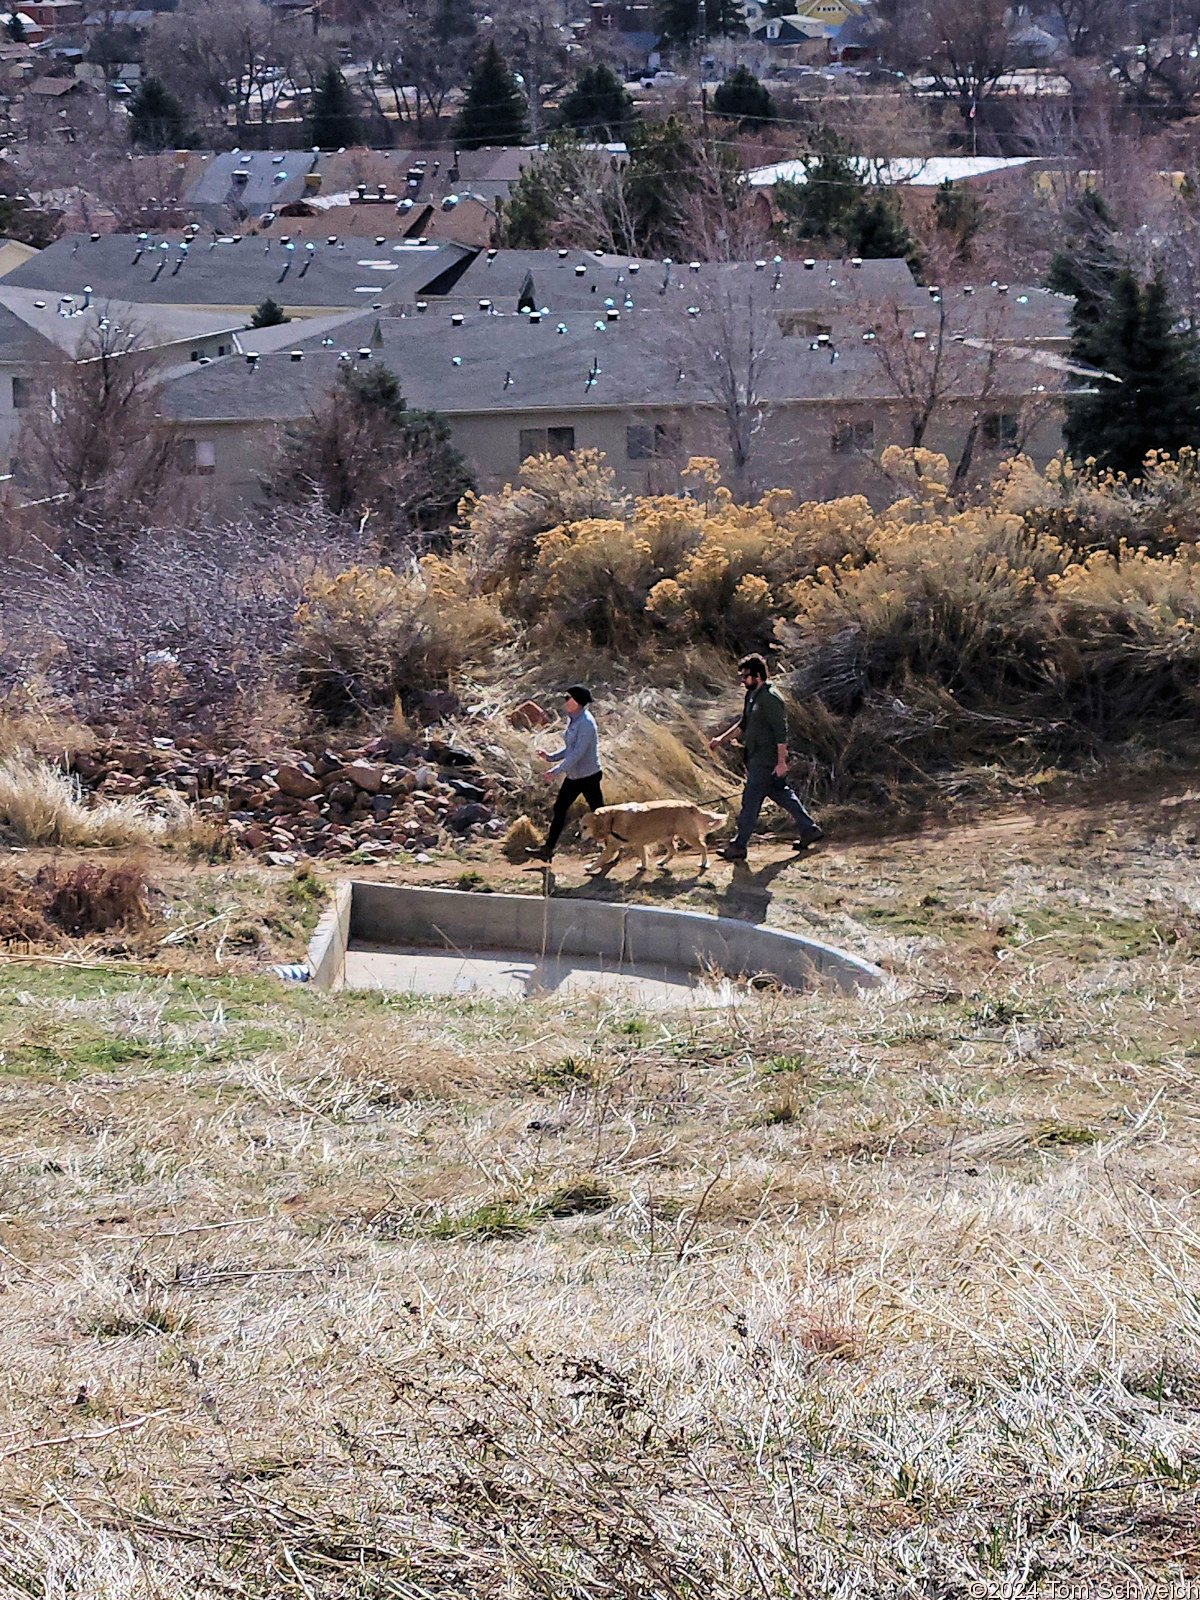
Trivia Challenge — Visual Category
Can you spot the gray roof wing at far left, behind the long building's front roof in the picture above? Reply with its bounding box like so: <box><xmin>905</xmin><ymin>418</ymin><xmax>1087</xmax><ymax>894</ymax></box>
<box><xmin>5</xmin><ymin>232</ymin><xmax>472</xmax><ymax>310</ymax></box>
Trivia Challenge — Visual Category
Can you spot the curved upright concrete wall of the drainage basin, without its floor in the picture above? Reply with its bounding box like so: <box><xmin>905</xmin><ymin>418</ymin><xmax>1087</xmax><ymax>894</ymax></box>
<box><xmin>309</xmin><ymin>883</ymin><xmax>883</xmax><ymax>989</ymax></box>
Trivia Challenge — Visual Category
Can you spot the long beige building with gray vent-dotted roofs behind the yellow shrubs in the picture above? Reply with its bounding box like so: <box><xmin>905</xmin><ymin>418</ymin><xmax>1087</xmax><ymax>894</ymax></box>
<box><xmin>0</xmin><ymin>233</ymin><xmax>1078</xmax><ymax>507</ymax></box>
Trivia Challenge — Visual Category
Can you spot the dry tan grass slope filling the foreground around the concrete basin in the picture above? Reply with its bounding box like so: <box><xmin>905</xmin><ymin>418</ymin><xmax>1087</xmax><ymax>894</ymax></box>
<box><xmin>0</xmin><ymin>797</ymin><xmax>1200</xmax><ymax>1600</ymax></box>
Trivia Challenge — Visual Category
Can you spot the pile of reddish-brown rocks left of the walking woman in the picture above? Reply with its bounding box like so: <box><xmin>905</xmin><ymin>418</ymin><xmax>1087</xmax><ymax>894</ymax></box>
<box><xmin>70</xmin><ymin>738</ymin><xmax>515</xmax><ymax>856</ymax></box>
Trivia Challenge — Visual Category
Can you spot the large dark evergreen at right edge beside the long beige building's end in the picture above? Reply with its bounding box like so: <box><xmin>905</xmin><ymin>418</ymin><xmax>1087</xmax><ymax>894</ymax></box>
<box><xmin>1066</xmin><ymin>267</ymin><xmax>1200</xmax><ymax>477</ymax></box>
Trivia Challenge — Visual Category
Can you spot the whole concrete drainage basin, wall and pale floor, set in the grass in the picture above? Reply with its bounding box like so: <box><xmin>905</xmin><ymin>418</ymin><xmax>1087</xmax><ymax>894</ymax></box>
<box><xmin>309</xmin><ymin>882</ymin><xmax>883</xmax><ymax>1005</ymax></box>
